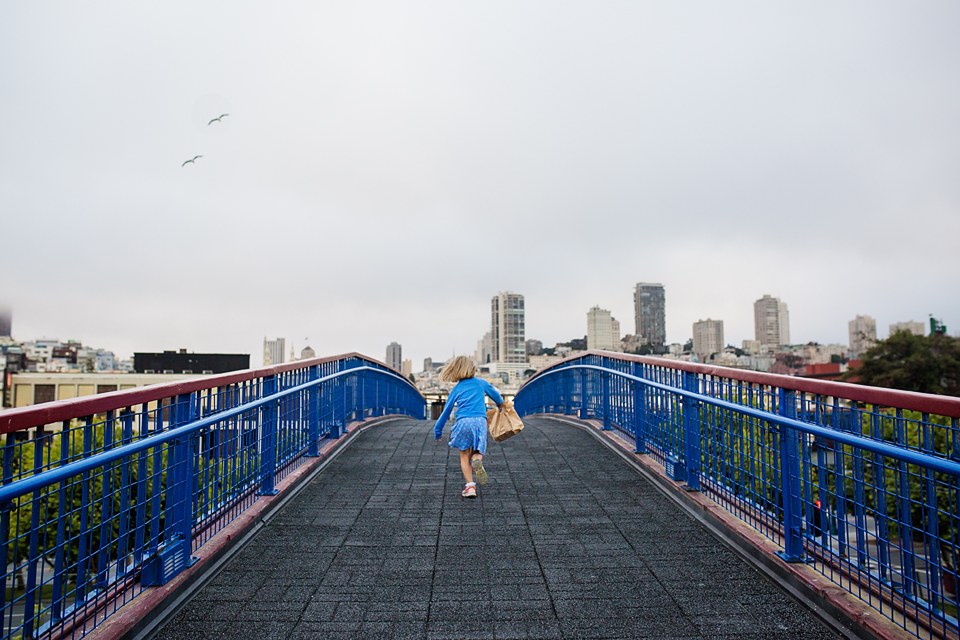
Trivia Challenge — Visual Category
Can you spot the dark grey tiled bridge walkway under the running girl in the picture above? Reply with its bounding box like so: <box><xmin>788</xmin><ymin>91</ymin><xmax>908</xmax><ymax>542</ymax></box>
<box><xmin>159</xmin><ymin>418</ymin><xmax>835</xmax><ymax>640</ymax></box>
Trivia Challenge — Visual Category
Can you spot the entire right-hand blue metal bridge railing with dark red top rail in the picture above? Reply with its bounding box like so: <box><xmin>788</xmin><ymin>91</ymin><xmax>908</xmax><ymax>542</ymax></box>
<box><xmin>515</xmin><ymin>352</ymin><xmax>960</xmax><ymax>637</ymax></box>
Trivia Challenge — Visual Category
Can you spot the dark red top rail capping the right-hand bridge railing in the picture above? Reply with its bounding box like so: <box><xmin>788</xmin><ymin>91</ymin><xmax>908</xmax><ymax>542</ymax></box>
<box><xmin>520</xmin><ymin>349</ymin><xmax>960</xmax><ymax>418</ymax></box>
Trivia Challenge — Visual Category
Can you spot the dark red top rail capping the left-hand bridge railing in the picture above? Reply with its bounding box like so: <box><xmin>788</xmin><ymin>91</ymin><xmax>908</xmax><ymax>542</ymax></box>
<box><xmin>0</xmin><ymin>352</ymin><xmax>419</xmax><ymax>433</ymax></box>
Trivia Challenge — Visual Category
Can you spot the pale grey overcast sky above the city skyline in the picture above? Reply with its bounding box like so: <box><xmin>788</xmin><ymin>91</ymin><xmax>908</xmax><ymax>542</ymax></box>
<box><xmin>0</xmin><ymin>0</ymin><xmax>960</xmax><ymax>370</ymax></box>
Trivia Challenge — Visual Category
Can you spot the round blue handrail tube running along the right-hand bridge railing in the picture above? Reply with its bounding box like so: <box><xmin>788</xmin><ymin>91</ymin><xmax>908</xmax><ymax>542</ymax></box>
<box><xmin>528</xmin><ymin>364</ymin><xmax>960</xmax><ymax>478</ymax></box>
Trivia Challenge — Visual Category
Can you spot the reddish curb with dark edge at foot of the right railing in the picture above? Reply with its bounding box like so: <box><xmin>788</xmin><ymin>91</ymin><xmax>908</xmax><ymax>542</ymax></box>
<box><xmin>538</xmin><ymin>414</ymin><xmax>917</xmax><ymax>640</ymax></box>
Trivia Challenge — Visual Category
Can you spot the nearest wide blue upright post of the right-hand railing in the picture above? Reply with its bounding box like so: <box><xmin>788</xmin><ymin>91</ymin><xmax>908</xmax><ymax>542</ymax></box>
<box><xmin>777</xmin><ymin>388</ymin><xmax>806</xmax><ymax>562</ymax></box>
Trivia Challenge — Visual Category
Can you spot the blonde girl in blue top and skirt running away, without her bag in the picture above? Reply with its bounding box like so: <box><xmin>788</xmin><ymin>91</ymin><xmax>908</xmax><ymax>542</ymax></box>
<box><xmin>433</xmin><ymin>356</ymin><xmax>503</xmax><ymax>498</ymax></box>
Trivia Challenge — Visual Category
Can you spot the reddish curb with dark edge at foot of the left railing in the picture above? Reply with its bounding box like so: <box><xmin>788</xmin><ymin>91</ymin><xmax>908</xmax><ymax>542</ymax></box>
<box><xmin>85</xmin><ymin>415</ymin><xmax>408</xmax><ymax>640</ymax></box>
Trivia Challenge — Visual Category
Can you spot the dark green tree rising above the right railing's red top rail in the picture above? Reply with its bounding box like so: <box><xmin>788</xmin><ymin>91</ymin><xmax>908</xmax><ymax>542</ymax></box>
<box><xmin>842</xmin><ymin>331</ymin><xmax>960</xmax><ymax>396</ymax></box>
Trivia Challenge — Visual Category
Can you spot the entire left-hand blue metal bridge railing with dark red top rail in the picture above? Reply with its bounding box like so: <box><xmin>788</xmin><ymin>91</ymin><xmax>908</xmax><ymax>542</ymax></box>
<box><xmin>0</xmin><ymin>354</ymin><xmax>426</xmax><ymax>638</ymax></box>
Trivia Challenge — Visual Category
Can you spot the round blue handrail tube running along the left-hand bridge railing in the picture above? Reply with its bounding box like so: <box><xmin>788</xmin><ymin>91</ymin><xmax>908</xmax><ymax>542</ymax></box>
<box><xmin>0</xmin><ymin>366</ymin><xmax>409</xmax><ymax>505</ymax></box>
